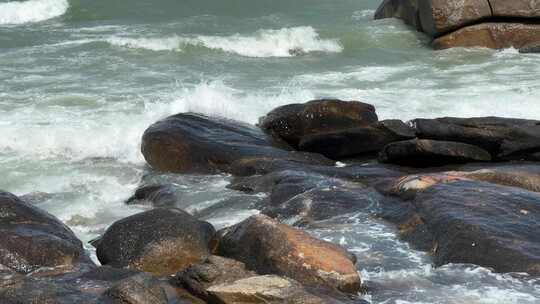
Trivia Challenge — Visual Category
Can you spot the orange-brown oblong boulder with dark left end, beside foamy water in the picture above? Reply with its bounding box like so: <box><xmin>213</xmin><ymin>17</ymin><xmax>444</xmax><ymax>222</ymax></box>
<box><xmin>217</xmin><ymin>215</ymin><xmax>361</xmax><ymax>293</ymax></box>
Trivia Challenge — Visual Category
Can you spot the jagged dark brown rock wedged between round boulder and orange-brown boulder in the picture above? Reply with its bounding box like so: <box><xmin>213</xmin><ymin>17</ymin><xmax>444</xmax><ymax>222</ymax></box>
<box><xmin>171</xmin><ymin>255</ymin><xmax>256</xmax><ymax>302</ymax></box>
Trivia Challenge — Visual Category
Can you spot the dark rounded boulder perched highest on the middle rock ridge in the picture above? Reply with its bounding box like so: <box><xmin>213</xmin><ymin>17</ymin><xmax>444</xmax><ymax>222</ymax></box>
<box><xmin>259</xmin><ymin>99</ymin><xmax>378</xmax><ymax>147</ymax></box>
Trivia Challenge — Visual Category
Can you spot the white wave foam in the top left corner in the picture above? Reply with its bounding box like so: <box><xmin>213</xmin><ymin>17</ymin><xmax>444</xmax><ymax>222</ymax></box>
<box><xmin>0</xmin><ymin>0</ymin><xmax>69</xmax><ymax>25</ymax></box>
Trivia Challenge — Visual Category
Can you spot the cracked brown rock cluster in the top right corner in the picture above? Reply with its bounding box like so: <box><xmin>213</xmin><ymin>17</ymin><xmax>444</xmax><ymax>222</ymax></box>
<box><xmin>375</xmin><ymin>0</ymin><xmax>540</xmax><ymax>52</ymax></box>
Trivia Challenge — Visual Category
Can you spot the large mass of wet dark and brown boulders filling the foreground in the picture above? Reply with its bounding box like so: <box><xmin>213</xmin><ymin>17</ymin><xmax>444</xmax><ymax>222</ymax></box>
<box><xmin>0</xmin><ymin>100</ymin><xmax>540</xmax><ymax>304</ymax></box>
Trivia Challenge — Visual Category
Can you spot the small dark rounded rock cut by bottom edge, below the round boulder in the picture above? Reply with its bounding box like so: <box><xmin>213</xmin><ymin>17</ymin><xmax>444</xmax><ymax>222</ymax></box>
<box><xmin>105</xmin><ymin>273</ymin><xmax>168</xmax><ymax>304</ymax></box>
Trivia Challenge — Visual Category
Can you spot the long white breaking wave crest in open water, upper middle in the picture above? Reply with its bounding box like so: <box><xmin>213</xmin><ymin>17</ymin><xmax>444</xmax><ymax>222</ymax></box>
<box><xmin>107</xmin><ymin>26</ymin><xmax>343</xmax><ymax>57</ymax></box>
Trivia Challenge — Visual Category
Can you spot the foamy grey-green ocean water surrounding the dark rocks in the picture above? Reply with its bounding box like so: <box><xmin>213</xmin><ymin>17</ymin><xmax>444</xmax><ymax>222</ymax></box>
<box><xmin>0</xmin><ymin>0</ymin><xmax>540</xmax><ymax>304</ymax></box>
